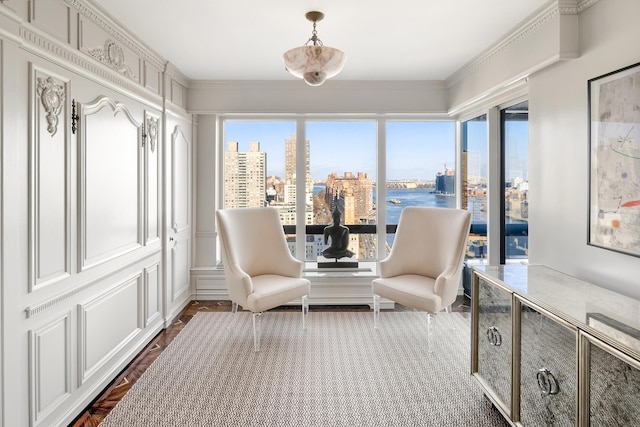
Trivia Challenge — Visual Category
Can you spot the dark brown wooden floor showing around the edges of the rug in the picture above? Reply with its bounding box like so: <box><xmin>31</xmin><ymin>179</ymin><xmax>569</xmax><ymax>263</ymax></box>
<box><xmin>70</xmin><ymin>296</ymin><xmax>470</xmax><ymax>427</ymax></box>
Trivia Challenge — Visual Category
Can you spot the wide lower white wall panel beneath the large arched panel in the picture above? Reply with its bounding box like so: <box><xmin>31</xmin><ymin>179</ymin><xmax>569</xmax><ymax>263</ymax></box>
<box><xmin>78</xmin><ymin>273</ymin><xmax>143</xmax><ymax>386</ymax></box>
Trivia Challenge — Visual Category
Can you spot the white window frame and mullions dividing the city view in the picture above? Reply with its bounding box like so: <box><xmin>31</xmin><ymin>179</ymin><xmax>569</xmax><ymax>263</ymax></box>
<box><xmin>214</xmin><ymin>107</ymin><xmax>528</xmax><ymax>263</ymax></box>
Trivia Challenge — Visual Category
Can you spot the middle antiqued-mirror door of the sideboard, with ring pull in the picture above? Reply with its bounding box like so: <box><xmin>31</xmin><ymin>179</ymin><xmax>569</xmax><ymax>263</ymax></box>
<box><xmin>520</xmin><ymin>304</ymin><xmax>578</xmax><ymax>426</ymax></box>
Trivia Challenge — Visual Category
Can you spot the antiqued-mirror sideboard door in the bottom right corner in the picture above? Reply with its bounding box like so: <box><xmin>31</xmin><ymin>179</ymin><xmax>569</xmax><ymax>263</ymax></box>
<box><xmin>585</xmin><ymin>335</ymin><xmax>640</xmax><ymax>426</ymax></box>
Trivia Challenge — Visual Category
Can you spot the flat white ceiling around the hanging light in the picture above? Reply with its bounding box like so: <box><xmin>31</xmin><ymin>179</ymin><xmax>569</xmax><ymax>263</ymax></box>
<box><xmin>93</xmin><ymin>0</ymin><xmax>549</xmax><ymax>80</ymax></box>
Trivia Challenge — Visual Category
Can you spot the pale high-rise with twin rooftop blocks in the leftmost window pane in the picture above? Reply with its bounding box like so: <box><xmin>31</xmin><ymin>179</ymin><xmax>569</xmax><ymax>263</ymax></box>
<box><xmin>224</xmin><ymin>141</ymin><xmax>267</xmax><ymax>208</ymax></box>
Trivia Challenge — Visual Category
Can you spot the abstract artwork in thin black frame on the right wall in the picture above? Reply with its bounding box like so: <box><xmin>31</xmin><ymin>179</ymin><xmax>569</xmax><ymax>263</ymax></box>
<box><xmin>587</xmin><ymin>63</ymin><xmax>640</xmax><ymax>256</ymax></box>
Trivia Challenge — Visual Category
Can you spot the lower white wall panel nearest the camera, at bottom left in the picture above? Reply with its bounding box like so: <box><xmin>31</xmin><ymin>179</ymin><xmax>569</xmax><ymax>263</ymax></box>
<box><xmin>29</xmin><ymin>313</ymin><xmax>71</xmax><ymax>425</ymax></box>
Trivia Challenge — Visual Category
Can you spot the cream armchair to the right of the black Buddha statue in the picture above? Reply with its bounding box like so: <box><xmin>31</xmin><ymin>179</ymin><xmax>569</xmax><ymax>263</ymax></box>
<box><xmin>372</xmin><ymin>206</ymin><xmax>471</xmax><ymax>328</ymax></box>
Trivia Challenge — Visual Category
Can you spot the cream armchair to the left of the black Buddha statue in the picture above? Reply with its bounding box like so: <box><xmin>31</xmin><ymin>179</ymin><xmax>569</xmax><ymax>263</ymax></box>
<box><xmin>216</xmin><ymin>207</ymin><xmax>310</xmax><ymax>351</ymax></box>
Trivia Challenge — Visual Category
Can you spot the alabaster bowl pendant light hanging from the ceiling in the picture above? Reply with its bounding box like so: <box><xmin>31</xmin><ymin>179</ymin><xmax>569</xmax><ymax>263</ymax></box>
<box><xmin>282</xmin><ymin>11</ymin><xmax>347</xmax><ymax>86</ymax></box>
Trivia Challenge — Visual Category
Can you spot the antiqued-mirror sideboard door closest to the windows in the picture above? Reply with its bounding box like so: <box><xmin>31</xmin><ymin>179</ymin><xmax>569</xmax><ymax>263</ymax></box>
<box><xmin>472</xmin><ymin>276</ymin><xmax>512</xmax><ymax>416</ymax></box>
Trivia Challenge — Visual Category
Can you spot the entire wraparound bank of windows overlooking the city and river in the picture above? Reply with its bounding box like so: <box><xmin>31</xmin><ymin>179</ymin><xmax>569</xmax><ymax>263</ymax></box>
<box><xmin>219</xmin><ymin>113</ymin><xmax>528</xmax><ymax>262</ymax></box>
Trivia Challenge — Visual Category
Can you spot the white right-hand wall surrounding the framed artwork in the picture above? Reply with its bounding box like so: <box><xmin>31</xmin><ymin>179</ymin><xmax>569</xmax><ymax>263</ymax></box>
<box><xmin>529</xmin><ymin>0</ymin><xmax>640</xmax><ymax>298</ymax></box>
